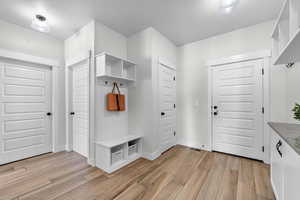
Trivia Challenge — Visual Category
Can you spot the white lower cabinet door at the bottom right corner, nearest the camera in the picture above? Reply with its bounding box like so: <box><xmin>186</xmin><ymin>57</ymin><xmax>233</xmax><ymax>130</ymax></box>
<box><xmin>283</xmin><ymin>142</ymin><xmax>300</xmax><ymax>200</ymax></box>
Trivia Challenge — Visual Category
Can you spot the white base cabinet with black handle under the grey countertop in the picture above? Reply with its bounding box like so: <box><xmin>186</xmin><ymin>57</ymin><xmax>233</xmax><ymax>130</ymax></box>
<box><xmin>271</xmin><ymin>130</ymin><xmax>300</xmax><ymax>200</ymax></box>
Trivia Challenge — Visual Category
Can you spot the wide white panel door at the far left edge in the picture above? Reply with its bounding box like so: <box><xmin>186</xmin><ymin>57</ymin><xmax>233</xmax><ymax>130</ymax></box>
<box><xmin>0</xmin><ymin>60</ymin><xmax>51</xmax><ymax>164</ymax></box>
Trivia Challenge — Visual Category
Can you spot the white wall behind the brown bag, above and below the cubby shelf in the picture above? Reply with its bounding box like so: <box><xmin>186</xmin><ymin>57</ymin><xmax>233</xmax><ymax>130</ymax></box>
<box><xmin>95</xmin><ymin>22</ymin><xmax>130</xmax><ymax>140</ymax></box>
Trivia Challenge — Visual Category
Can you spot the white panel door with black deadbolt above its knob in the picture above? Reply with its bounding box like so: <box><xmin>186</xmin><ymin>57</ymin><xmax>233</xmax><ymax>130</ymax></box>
<box><xmin>212</xmin><ymin>60</ymin><xmax>263</xmax><ymax>160</ymax></box>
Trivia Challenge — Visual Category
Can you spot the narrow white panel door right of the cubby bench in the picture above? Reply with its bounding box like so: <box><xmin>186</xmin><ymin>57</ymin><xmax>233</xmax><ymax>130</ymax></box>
<box><xmin>159</xmin><ymin>65</ymin><xmax>176</xmax><ymax>152</ymax></box>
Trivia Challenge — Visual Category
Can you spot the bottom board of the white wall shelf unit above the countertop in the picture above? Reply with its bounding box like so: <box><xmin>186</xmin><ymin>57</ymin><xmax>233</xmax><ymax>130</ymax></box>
<box><xmin>274</xmin><ymin>28</ymin><xmax>300</xmax><ymax>65</ymax></box>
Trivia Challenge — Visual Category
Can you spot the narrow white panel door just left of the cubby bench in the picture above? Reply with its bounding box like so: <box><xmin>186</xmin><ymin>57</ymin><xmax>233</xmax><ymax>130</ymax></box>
<box><xmin>72</xmin><ymin>60</ymin><xmax>89</xmax><ymax>157</ymax></box>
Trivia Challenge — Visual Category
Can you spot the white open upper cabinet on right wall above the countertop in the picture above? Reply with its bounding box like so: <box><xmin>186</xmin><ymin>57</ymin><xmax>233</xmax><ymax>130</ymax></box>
<box><xmin>272</xmin><ymin>0</ymin><xmax>300</xmax><ymax>65</ymax></box>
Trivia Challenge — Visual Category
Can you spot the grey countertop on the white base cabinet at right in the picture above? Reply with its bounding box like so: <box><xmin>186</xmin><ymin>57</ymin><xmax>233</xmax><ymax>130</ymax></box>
<box><xmin>268</xmin><ymin>122</ymin><xmax>300</xmax><ymax>155</ymax></box>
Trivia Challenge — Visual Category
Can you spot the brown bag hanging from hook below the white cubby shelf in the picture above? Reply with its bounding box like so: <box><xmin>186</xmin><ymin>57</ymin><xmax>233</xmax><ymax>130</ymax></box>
<box><xmin>107</xmin><ymin>83</ymin><xmax>125</xmax><ymax>111</ymax></box>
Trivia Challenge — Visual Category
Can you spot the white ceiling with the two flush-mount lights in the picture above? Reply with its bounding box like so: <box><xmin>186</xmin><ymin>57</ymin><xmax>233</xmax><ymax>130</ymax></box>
<box><xmin>0</xmin><ymin>0</ymin><xmax>283</xmax><ymax>45</ymax></box>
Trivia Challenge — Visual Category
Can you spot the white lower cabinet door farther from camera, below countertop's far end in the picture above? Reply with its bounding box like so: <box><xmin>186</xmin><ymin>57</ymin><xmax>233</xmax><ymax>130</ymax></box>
<box><xmin>271</xmin><ymin>131</ymin><xmax>283</xmax><ymax>200</ymax></box>
